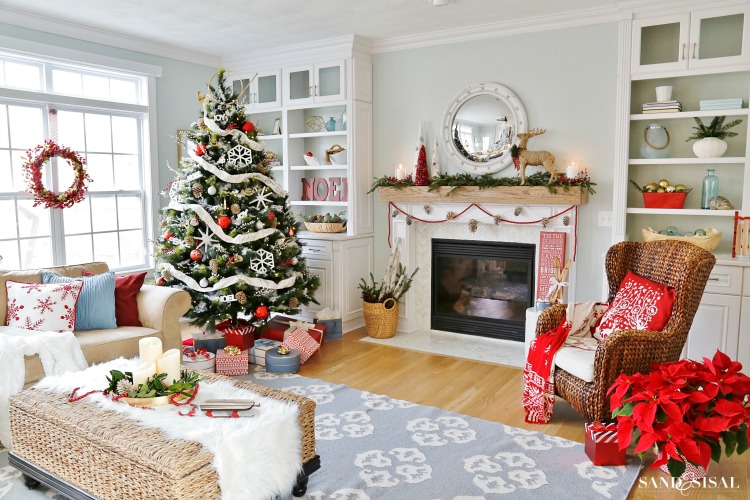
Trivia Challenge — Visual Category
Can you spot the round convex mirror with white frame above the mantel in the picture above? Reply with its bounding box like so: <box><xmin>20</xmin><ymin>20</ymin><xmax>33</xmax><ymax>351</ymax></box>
<box><xmin>443</xmin><ymin>82</ymin><xmax>528</xmax><ymax>174</ymax></box>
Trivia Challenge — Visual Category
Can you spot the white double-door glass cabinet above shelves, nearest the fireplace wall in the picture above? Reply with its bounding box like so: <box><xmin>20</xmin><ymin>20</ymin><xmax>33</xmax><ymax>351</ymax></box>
<box><xmin>284</xmin><ymin>59</ymin><xmax>346</xmax><ymax>105</ymax></box>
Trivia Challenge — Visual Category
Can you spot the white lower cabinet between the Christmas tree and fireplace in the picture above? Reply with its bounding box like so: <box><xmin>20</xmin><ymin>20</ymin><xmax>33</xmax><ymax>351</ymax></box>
<box><xmin>299</xmin><ymin>232</ymin><xmax>373</xmax><ymax>333</ymax></box>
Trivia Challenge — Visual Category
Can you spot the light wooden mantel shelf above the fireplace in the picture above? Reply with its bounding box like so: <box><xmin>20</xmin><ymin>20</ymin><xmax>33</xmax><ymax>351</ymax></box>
<box><xmin>378</xmin><ymin>186</ymin><xmax>589</xmax><ymax>205</ymax></box>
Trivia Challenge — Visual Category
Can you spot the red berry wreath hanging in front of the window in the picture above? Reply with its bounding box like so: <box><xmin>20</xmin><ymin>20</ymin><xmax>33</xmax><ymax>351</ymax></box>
<box><xmin>23</xmin><ymin>140</ymin><xmax>91</xmax><ymax>208</ymax></box>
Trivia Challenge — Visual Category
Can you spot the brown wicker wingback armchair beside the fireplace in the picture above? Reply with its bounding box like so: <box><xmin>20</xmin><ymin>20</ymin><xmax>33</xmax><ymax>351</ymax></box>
<box><xmin>536</xmin><ymin>240</ymin><xmax>716</xmax><ymax>422</ymax></box>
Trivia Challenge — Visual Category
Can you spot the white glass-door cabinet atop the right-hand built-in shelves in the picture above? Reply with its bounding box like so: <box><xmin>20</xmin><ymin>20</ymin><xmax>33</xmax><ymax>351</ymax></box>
<box><xmin>632</xmin><ymin>6</ymin><xmax>750</xmax><ymax>75</ymax></box>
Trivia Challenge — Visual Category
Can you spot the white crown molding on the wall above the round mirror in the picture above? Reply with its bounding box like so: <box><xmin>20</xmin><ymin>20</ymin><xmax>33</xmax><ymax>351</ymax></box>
<box><xmin>372</xmin><ymin>6</ymin><xmax>629</xmax><ymax>54</ymax></box>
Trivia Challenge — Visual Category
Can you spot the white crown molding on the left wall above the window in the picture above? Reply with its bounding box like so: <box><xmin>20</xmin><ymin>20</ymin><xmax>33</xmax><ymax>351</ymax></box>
<box><xmin>0</xmin><ymin>6</ymin><xmax>221</xmax><ymax>67</ymax></box>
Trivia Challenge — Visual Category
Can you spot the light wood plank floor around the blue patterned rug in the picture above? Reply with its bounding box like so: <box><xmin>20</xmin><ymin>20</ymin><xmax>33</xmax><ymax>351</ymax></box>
<box><xmin>184</xmin><ymin>329</ymin><xmax>750</xmax><ymax>500</ymax></box>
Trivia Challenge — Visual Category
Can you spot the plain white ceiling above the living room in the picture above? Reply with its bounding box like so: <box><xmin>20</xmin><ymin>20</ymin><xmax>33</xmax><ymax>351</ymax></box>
<box><xmin>0</xmin><ymin>0</ymin><xmax>619</xmax><ymax>60</ymax></box>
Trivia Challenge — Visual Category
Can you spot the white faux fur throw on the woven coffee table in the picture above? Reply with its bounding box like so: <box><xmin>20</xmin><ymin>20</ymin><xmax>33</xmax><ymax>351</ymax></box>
<box><xmin>36</xmin><ymin>358</ymin><xmax>302</xmax><ymax>500</ymax></box>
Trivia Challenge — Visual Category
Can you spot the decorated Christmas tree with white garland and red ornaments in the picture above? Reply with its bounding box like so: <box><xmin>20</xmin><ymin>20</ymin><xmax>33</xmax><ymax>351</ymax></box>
<box><xmin>155</xmin><ymin>70</ymin><xmax>319</xmax><ymax>331</ymax></box>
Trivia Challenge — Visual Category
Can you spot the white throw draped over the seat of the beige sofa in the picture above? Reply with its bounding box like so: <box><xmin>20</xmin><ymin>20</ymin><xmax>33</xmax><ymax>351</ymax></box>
<box><xmin>0</xmin><ymin>326</ymin><xmax>88</xmax><ymax>448</ymax></box>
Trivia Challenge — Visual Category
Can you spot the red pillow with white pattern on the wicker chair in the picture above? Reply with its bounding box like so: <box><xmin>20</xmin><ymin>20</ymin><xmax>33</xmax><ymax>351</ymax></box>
<box><xmin>594</xmin><ymin>271</ymin><xmax>674</xmax><ymax>340</ymax></box>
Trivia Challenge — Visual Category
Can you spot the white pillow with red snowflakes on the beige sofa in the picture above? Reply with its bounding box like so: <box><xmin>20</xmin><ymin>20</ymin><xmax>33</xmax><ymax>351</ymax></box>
<box><xmin>5</xmin><ymin>280</ymin><xmax>83</xmax><ymax>332</ymax></box>
